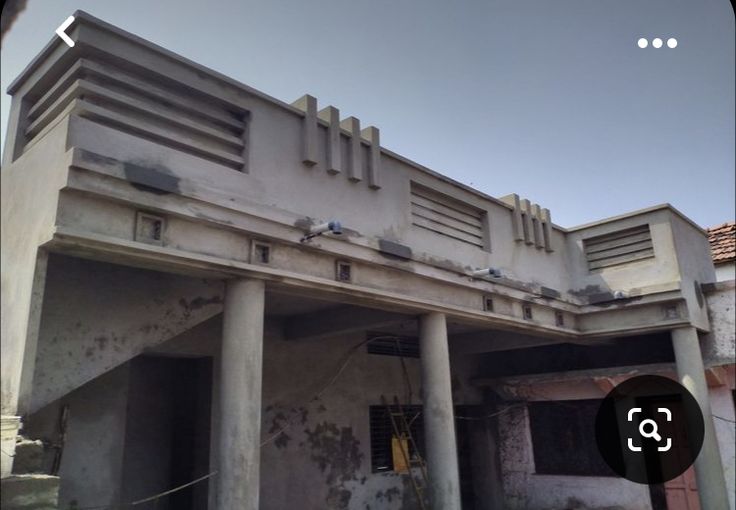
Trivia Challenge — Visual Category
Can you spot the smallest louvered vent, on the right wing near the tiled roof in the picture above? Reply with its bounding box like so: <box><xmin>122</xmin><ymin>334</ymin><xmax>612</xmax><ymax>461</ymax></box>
<box><xmin>583</xmin><ymin>225</ymin><xmax>654</xmax><ymax>270</ymax></box>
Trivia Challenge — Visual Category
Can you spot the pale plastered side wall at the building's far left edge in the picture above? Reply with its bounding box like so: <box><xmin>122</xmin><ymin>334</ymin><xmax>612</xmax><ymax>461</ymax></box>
<box><xmin>0</xmin><ymin>116</ymin><xmax>67</xmax><ymax>415</ymax></box>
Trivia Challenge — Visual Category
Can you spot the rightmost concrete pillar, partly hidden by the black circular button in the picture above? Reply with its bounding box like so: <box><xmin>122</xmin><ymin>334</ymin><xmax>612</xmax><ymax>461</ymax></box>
<box><xmin>672</xmin><ymin>327</ymin><xmax>728</xmax><ymax>510</ymax></box>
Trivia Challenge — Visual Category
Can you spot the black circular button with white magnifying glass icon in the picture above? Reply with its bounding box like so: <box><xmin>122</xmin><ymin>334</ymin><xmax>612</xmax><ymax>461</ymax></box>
<box><xmin>595</xmin><ymin>375</ymin><xmax>704</xmax><ymax>484</ymax></box>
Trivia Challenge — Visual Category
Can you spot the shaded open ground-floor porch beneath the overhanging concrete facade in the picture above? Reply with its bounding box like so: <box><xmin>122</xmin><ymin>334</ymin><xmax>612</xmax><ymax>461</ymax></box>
<box><xmin>2</xmin><ymin>254</ymin><xmax>735</xmax><ymax>510</ymax></box>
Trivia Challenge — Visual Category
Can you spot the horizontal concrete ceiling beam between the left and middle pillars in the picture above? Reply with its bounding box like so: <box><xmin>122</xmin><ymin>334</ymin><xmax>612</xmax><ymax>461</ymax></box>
<box><xmin>284</xmin><ymin>306</ymin><xmax>415</xmax><ymax>340</ymax></box>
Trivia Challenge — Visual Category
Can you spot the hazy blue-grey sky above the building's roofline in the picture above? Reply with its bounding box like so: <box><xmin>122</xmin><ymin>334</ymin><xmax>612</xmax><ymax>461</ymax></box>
<box><xmin>1</xmin><ymin>0</ymin><xmax>736</xmax><ymax>226</ymax></box>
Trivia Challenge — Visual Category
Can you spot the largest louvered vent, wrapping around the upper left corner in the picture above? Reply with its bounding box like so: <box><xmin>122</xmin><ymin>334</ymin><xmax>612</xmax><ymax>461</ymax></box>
<box><xmin>24</xmin><ymin>58</ymin><xmax>248</xmax><ymax>170</ymax></box>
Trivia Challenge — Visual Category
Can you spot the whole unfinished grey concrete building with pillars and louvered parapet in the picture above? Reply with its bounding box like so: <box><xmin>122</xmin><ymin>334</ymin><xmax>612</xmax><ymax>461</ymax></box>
<box><xmin>2</xmin><ymin>12</ymin><xmax>734</xmax><ymax>510</ymax></box>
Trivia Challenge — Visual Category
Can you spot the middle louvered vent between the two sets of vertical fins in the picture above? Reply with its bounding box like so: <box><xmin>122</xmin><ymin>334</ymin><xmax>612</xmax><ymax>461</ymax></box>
<box><xmin>411</xmin><ymin>183</ymin><xmax>486</xmax><ymax>248</ymax></box>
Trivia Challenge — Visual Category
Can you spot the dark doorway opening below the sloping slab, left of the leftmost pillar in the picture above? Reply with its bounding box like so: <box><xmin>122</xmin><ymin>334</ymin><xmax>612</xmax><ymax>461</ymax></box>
<box><xmin>121</xmin><ymin>356</ymin><xmax>212</xmax><ymax>510</ymax></box>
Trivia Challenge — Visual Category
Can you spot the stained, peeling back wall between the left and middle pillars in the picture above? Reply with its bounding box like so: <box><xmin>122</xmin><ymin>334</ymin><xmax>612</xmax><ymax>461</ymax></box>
<box><xmin>261</xmin><ymin>326</ymin><xmax>480</xmax><ymax>510</ymax></box>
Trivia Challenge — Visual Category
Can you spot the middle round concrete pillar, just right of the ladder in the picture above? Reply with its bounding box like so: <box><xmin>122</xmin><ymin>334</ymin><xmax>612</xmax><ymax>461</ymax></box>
<box><xmin>419</xmin><ymin>312</ymin><xmax>460</xmax><ymax>510</ymax></box>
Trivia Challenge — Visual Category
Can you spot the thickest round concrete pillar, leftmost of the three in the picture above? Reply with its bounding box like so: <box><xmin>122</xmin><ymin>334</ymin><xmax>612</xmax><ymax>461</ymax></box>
<box><xmin>217</xmin><ymin>280</ymin><xmax>265</xmax><ymax>510</ymax></box>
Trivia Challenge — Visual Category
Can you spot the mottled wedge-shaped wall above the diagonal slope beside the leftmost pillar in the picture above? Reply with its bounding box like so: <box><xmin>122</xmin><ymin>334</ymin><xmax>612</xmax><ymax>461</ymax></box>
<box><xmin>30</xmin><ymin>256</ymin><xmax>223</xmax><ymax>410</ymax></box>
